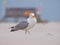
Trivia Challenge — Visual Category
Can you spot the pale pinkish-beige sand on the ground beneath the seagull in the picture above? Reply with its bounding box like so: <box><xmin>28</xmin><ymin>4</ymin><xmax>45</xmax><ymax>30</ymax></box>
<box><xmin>0</xmin><ymin>22</ymin><xmax>60</xmax><ymax>45</ymax></box>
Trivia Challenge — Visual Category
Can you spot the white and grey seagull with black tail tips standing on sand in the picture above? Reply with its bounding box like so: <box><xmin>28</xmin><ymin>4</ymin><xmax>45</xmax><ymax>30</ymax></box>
<box><xmin>10</xmin><ymin>12</ymin><xmax>37</xmax><ymax>33</ymax></box>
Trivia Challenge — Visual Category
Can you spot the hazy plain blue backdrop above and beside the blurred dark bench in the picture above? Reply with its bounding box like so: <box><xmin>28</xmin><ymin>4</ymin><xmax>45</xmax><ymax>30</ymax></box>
<box><xmin>0</xmin><ymin>0</ymin><xmax>60</xmax><ymax>21</ymax></box>
